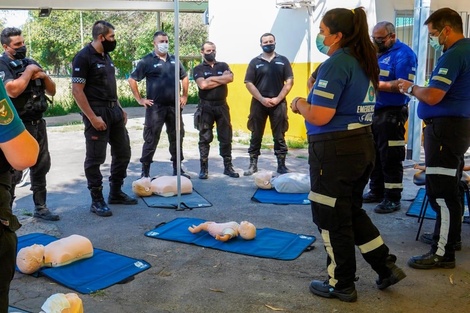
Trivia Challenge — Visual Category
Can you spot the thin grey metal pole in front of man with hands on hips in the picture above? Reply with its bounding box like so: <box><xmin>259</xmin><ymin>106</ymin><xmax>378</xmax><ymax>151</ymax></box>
<box><xmin>174</xmin><ymin>0</ymin><xmax>181</xmax><ymax>211</ymax></box>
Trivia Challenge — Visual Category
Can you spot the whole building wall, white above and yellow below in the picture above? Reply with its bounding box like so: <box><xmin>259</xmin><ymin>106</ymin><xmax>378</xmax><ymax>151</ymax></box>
<box><xmin>208</xmin><ymin>0</ymin><xmax>377</xmax><ymax>140</ymax></box>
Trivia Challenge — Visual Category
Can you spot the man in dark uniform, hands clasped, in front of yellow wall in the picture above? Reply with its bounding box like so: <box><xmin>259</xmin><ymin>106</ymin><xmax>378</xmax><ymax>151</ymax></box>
<box><xmin>243</xmin><ymin>33</ymin><xmax>294</xmax><ymax>176</ymax></box>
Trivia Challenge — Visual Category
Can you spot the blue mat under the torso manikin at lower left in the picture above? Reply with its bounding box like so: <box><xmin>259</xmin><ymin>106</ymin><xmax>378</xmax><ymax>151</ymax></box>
<box><xmin>17</xmin><ymin>233</ymin><xmax>151</xmax><ymax>294</ymax></box>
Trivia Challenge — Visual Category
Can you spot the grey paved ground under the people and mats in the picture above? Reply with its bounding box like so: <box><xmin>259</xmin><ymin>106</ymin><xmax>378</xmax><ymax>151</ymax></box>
<box><xmin>10</xmin><ymin>107</ymin><xmax>470</xmax><ymax>313</ymax></box>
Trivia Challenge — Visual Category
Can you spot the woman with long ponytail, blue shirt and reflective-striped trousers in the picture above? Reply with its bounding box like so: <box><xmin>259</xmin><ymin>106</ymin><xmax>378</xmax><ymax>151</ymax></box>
<box><xmin>291</xmin><ymin>8</ymin><xmax>406</xmax><ymax>302</ymax></box>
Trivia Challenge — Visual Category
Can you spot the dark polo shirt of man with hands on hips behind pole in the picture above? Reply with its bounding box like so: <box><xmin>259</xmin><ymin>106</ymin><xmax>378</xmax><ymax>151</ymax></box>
<box><xmin>131</xmin><ymin>51</ymin><xmax>188</xmax><ymax>105</ymax></box>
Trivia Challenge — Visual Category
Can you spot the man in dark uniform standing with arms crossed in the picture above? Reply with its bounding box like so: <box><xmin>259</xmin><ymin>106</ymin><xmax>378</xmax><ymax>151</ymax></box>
<box><xmin>193</xmin><ymin>41</ymin><xmax>240</xmax><ymax>179</ymax></box>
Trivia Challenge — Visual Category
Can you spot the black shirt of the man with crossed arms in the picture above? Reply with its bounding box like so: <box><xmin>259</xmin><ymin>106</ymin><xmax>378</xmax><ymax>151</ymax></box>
<box><xmin>193</xmin><ymin>61</ymin><xmax>230</xmax><ymax>101</ymax></box>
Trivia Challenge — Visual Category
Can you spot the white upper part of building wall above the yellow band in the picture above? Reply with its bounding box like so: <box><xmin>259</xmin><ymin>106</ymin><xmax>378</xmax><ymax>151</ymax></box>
<box><xmin>209</xmin><ymin>0</ymin><xmax>378</xmax><ymax>64</ymax></box>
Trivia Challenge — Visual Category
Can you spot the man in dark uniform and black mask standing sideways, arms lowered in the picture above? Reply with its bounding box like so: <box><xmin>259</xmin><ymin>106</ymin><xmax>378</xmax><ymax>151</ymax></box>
<box><xmin>72</xmin><ymin>21</ymin><xmax>137</xmax><ymax>216</ymax></box>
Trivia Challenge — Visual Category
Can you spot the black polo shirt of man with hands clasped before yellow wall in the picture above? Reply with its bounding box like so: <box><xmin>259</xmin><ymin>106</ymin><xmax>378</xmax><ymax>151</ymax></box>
<box><xmin>245</xmin><ymin>53</ymin><xmax>294</xmax><ymax>98</ymax></box>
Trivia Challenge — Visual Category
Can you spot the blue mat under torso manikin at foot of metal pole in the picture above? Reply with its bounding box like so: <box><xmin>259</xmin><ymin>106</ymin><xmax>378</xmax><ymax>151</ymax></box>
<box><xmin>142</xmin><ymin>189</ymin><xmax>212</xmax><ymax>210</ymax></box>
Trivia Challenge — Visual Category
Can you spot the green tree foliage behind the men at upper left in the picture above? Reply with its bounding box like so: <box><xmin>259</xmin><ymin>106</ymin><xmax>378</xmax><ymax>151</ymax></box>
<box><xmin>23</xmin><ymin>10</ymin><xmax>207</xmax><ymax>77</ymax></box>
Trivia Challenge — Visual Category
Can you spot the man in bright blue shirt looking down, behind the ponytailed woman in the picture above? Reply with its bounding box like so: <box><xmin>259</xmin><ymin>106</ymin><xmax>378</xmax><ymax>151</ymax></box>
<box><xmin>363</xmin><ymin>22</ymin><xmax>418</xmax><ymax>214</ymax></box>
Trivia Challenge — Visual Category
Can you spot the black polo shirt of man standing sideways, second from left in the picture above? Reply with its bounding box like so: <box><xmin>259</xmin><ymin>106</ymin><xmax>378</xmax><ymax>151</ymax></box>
<box><xmin>72</xmin><ymin>43</ymin><xmax>117</xmax><ymax>102</ymax></box>
